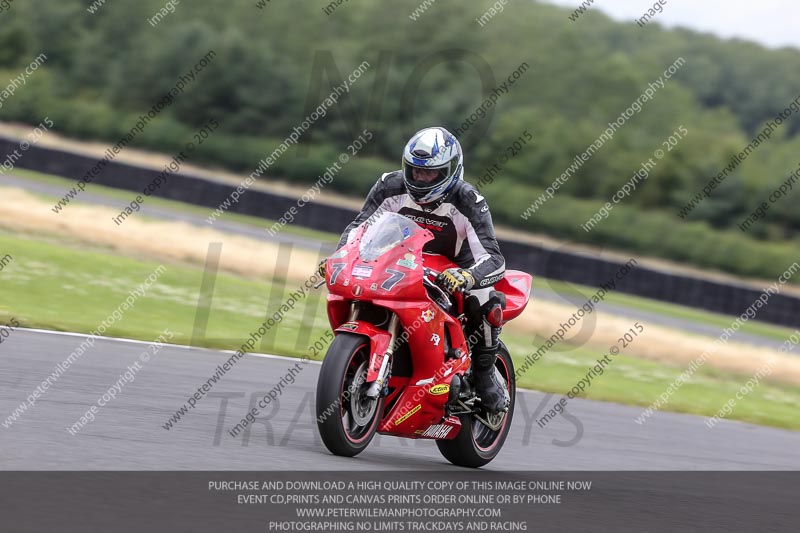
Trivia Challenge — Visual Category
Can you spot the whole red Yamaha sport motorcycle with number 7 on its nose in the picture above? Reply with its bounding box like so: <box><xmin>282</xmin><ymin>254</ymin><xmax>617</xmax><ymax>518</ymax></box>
<box><xmin>317</xmin><ymin>213</ymin><xmax>532</xmax><ymax>467</ymax></box>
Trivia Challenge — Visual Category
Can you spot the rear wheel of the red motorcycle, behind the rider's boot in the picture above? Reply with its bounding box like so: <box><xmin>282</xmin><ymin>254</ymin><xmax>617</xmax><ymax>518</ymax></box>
<box><xmin>436</xmin><ymin>342</ymin><xmax>517</xmax><ymax>468</ymax></box>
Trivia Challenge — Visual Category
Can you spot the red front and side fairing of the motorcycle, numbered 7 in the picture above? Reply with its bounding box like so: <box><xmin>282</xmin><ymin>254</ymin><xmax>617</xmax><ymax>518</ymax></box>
<box><xmin>327</xmin><ymin>213</ymin><xmax>470</xmax><ymax>439</ymax></box>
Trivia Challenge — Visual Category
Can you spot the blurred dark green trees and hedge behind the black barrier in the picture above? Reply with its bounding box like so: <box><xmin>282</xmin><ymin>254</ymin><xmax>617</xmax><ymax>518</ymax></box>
<box><xmin>0</xmin><ymin>0</ymin><xmax>800</xmax><ymax>276</ymax></box>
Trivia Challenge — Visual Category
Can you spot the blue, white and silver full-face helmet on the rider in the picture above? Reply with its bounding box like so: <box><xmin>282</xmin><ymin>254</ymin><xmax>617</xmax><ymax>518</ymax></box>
<box><xmin>403</xmin><ymin>128</ymin><xmax>464</xmax><ymax>205</ymax></box>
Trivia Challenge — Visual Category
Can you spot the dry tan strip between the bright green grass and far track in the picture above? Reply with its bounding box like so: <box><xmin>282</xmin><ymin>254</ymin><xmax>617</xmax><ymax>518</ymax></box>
<box><xmin>0</xmin><ymin>187</ymin><xmax>800</xmax><ymax>385</ymax></box>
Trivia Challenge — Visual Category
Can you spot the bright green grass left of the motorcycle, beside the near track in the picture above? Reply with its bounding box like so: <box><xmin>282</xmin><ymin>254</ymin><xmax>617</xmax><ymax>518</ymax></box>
<box><xmin>0</xmin><ymin>227</ymin><xmax>326</xmax><ymax>355</ymax></box>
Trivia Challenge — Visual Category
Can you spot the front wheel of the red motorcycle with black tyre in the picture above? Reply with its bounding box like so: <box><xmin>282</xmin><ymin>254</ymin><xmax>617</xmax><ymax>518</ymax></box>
<box><xmin>316</xmin><ymin>333</ymin><xmax>383</xmax><ymax>457</ymax></box>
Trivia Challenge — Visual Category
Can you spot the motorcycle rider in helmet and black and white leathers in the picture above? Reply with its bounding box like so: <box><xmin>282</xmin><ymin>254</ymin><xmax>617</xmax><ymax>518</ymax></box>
<box><xmin>320</xmin><ymin>127</ymin><xmax>509</xmax><ymax>413</ymax></box>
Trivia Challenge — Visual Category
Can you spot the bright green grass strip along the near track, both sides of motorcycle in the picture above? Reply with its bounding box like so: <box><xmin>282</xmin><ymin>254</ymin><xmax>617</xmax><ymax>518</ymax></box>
<box><xmin>0</xmin><ymin>231</ymin><xmax>800</xmax><ymax>430</ymax></box>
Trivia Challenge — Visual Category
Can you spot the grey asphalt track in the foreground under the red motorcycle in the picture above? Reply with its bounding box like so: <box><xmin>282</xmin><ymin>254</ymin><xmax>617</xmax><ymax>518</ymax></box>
<box><xmin>0</xmin><ymin>329</ymin><xmax>800</xmax><ymax>471</ymax></box>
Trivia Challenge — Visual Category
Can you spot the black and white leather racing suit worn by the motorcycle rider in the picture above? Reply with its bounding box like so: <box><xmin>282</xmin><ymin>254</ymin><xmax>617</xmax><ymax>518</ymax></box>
<box><xmin>339</xmin><ymin>170</ymin><xmax>505</xmax><ymax>392</ymax></box>
